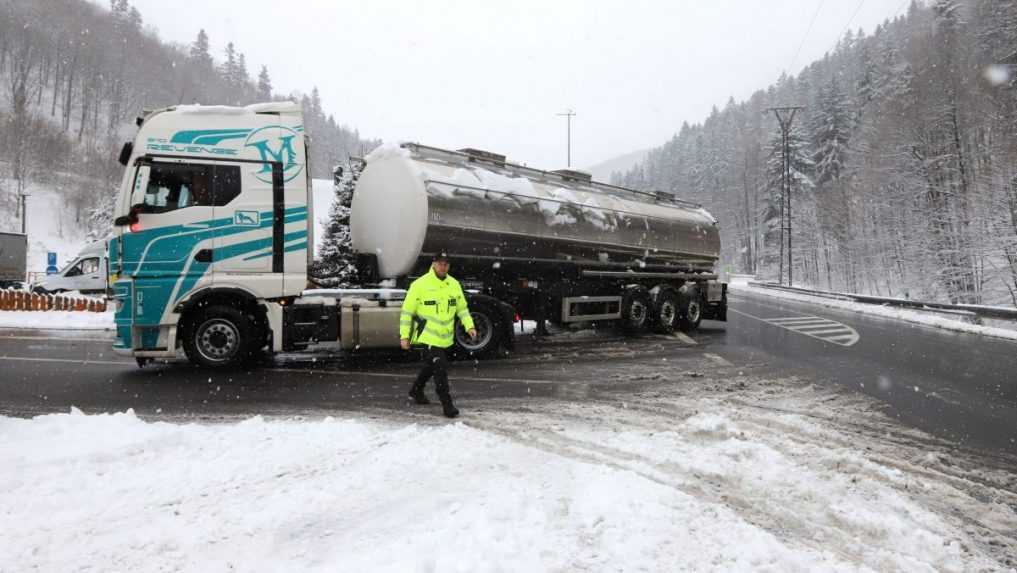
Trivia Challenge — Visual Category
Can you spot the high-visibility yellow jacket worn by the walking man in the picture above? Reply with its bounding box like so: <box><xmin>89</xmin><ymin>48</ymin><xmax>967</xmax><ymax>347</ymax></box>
<box><xmin>399</xmin><ymin>269</ymin><xmax>473</xmax><ymax>348</ymax></box>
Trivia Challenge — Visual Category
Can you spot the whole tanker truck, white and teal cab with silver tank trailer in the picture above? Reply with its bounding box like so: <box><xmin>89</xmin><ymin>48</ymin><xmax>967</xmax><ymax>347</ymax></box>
<box><xmin>109</xmin><ymin>102</ymin><xmax>727</xmax><ymax>367</ymax></box>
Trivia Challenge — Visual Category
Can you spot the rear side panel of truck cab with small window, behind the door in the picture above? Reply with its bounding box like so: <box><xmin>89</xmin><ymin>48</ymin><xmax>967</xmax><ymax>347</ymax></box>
<box><xmin>212</xmin><ymin>162</ymin><xmax>284</xmax><ymax>297</ymax></box>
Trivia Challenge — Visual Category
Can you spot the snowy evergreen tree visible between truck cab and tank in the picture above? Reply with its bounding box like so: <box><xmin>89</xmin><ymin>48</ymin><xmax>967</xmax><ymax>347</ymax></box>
<box><xmin>313</xmin><ymin>162</ymin><xmax>363</xmax><ymax>287</ymax></box>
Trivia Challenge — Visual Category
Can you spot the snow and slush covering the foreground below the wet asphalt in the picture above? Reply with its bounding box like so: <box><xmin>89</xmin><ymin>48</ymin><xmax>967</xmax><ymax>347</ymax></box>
<box><xmin>0</xmin><ymin>370</ymin><xmax>1017</xmax><ymax>572</ymax></box>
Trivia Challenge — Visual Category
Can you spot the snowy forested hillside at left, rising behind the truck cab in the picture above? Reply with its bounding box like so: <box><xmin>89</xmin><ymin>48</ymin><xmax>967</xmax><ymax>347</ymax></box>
<box><xmin>0</xmin><ymin>0</ymin><xmax>373</xmax><ymax>236</ymax></box>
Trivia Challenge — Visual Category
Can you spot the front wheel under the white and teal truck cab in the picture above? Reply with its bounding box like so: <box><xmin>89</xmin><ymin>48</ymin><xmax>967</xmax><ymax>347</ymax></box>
<box><xmin>183</xmin><ymin>305</ymin><xmax>264</xmax><ymax>368</ymax></box>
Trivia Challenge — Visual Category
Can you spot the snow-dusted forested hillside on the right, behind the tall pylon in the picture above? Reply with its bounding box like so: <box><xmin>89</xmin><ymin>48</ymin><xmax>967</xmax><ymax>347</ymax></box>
<box><xmin>613</xmin><ymin>0</ymin><xmax>1017</xmax><ymax>304</ymax></box>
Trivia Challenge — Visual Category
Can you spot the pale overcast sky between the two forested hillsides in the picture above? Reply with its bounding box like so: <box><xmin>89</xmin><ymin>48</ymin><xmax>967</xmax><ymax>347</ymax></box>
<box><xmin>125</xmin><ymin>0</ymin><xmax>907</xmax><ymax>169</ymax></box>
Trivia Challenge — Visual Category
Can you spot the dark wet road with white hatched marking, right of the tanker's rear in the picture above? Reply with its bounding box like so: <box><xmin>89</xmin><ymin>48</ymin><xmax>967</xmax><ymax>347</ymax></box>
<box><xmin>718</xmin><ymin>291</ymin><xmax>1017</xmax><ymax>454</ymax></box>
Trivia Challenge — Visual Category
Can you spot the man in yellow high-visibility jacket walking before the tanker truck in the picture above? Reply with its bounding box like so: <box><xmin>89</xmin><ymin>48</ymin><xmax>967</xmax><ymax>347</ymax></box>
<box><xmin>399</xmin><ymin>250</ymin><xmax>477</xmax><ymax>418</ymax></box>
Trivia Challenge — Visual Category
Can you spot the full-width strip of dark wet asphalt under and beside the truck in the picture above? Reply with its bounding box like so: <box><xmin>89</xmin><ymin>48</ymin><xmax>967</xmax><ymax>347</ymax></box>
<box><xmin>0</xmin><ymin>292</ymin><xmax>1017</xmax><ymax>453</ymax></box>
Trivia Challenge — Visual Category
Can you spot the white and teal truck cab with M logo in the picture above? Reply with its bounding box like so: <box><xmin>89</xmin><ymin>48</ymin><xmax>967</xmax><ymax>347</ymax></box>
<box><xmin>109</xmin><ymin>102</ymin><xmax>313</xmax><ymax>365</ymax></box>
